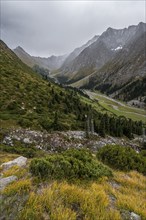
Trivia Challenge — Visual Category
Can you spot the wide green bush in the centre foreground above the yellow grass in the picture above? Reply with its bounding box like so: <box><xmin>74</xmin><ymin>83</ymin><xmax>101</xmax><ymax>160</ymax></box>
<box><xmin>30</xmin><ymin>149</ymin><xmax>112</xmax><ymax>180</ymax></box>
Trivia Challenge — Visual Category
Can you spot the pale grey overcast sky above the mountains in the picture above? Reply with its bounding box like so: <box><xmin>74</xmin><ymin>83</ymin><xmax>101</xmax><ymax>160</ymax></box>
<box><xmin>1</xmin><ymin>0</ymin><xmax>146</xmax><ymax>57</ymax></box>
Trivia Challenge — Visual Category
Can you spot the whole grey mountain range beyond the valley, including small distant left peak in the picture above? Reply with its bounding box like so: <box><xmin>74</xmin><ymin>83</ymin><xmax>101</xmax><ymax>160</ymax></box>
<box><xmin>14</xmin><ymin>22</ymin><xmax>146</xmax><ymax>101</ymax></box>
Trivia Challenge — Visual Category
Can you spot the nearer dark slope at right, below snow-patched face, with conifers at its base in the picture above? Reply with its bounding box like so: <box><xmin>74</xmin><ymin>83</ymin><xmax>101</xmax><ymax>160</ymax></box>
<box><xmin>80</xmin><ymin>32</ymin><xmax>146</xmax><ymax>101</ymax></box>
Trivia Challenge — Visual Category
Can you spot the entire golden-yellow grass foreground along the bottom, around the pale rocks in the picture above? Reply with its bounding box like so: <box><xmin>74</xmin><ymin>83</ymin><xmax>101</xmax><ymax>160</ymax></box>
<box><xmin>0</xmin><ymin>153</ymin><xmax>146</xmax><ymax>220</ymax></box>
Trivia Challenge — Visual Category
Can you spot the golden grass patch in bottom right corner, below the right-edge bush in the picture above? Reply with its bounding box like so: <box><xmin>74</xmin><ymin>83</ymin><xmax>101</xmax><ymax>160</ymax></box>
<box><xmin>107</xmin><ymin>171</ymin><xmax>146</xmax><ymax>220</ymax></box>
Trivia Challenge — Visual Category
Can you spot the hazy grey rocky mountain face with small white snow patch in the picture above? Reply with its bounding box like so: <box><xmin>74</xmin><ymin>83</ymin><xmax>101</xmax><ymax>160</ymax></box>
<box><xmin>56</xmin><ymin>22</ymin><xmax>146</xmax><ymax>83</ymax></box>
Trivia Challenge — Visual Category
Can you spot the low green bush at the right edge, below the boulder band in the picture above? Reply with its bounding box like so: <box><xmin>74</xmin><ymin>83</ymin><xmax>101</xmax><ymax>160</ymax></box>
<box><xmin>97</xmin><ymin>145</ymin><xmax>146</xmax><ymax>174</ymax></box>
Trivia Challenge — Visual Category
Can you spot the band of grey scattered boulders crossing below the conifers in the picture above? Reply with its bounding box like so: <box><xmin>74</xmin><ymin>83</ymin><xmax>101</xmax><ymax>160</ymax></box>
<box><xmin>1</xmin><ymin>129</ymin><xmax>139</xmax><ymax>153</ymax></box>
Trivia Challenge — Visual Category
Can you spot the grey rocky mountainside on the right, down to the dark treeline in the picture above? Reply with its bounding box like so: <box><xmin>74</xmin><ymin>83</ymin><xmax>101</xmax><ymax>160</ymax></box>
<box><xmin>56</xmin><ymin>22</ymin><xmax>146</xmax><ymax>88</ymax></box>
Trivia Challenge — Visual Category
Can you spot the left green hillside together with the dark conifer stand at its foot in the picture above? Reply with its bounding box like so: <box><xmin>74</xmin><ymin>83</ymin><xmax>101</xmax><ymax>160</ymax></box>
<box><xmin>0</xmin><ymin>41</ymin><xmax>142</xmax><ymax>138</ymax></box>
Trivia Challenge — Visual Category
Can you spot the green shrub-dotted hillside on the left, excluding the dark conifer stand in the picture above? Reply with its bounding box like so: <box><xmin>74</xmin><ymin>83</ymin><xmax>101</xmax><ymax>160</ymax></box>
<box><xmin>0</xmin><ymin>41</ymin><xmax>93</xmax><ymax>130</ymax></box>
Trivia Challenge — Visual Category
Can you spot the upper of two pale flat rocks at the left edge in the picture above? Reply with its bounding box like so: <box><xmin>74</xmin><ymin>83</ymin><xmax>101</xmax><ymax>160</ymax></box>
<box><xmin>1</xmin><ymin>156</ymin><xmax>27</xmax><ymax>170</ymax></box>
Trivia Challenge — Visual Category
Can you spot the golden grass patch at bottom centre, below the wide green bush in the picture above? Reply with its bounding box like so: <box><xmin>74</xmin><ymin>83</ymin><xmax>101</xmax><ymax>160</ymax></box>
<box><xmin>20</xmin><ymin>182</ymin><xmax>121</xmax><ymax>220</ymax></box>
